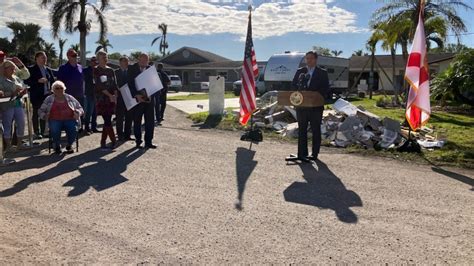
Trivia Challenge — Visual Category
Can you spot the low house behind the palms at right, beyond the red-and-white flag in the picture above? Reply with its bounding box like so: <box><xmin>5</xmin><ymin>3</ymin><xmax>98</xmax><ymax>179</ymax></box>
<box><xmin>349</xmin><ymin>53</ymin><xmax>455</xmax><ymax>91</ymax></box>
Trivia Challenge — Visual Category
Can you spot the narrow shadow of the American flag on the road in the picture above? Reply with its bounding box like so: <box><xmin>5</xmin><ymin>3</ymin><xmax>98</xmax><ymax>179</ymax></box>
<box><xmin>235</xmin><ymin>147</ymin><xmax>258</xmax><ymax>211</ymax></box>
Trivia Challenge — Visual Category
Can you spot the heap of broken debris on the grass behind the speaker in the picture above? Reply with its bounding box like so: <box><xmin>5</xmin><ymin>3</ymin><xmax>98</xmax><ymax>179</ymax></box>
<box><xmin>253</xmin><ymin>91</ymin><xmax>446</xmax><ymax>149</ymax></box>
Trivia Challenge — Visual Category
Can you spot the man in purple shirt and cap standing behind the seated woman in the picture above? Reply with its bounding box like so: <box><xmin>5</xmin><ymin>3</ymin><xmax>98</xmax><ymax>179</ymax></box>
<box><xmin>58</xmin><ymin>49</ymin><xmax>84</xmax><ymax>132</ymax></box>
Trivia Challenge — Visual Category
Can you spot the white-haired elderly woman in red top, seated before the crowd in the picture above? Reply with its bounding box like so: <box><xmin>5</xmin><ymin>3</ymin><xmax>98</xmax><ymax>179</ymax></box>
<box><xmin>38</xmin><ymin>81</ymin><xmax>84</xmax><ymax>154</ymax></box>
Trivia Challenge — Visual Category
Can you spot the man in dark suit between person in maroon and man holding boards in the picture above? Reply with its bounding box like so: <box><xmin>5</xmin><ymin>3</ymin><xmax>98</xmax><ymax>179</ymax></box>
<box><xmin>115</xmin><ymin>56</ymin><xmax>133</xmax><ymax>141</ymax></box>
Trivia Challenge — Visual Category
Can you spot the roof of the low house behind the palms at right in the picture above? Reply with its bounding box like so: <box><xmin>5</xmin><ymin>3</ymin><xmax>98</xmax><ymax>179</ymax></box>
<box><xmin>349</xmin><ymin>53</ymin><xmax>456</xmax><ymax>69</ymax></box>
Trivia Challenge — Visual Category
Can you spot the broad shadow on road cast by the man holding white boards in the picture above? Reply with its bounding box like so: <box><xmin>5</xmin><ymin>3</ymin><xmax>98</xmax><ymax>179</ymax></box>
<box><xmin>63</xmin><ymin>148</ymin><xmax>144</xmax><ymax>197</ymax></box>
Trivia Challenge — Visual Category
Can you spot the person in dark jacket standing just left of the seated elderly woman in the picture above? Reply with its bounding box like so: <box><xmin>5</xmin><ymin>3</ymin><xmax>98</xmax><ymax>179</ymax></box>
<box><xmin>25</xmin><ymin>51</ymin><xmax>55</xmax><ymax>139</ymax></box>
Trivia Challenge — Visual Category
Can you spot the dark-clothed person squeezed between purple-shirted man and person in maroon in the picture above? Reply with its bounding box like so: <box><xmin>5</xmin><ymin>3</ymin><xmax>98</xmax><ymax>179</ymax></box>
<box><xmin>84</xmin><ymin>56</ymin><xmax>99</xmax><ymax>134</ymax></box>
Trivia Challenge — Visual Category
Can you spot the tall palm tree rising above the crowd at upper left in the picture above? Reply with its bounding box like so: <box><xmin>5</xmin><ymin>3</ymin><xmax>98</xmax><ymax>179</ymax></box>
<box><xmin>40</xmin><ymin>0</ymin><xmax>110</xmax><ymax>65</ymax></box>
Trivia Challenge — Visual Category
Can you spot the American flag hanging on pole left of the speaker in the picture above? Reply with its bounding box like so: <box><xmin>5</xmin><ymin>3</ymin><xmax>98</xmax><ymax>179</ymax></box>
<box><xmin>239</xmin><ymin>7</ymin><xmax>258</xmax><ymax>125</ymax></box>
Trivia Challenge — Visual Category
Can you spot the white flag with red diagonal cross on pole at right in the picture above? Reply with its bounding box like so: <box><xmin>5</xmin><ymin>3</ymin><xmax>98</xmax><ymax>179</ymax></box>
<box><xmin>405</xmin><ymin>0</ymin><xmax>431</xmax><ymax>130</ymax></box>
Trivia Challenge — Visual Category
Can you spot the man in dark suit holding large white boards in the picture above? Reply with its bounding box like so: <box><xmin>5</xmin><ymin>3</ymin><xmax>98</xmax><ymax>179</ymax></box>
<box><xmin>128</xmin><ymin>54</ymin><xmax>156</xmax><ymax>149</ymax></box>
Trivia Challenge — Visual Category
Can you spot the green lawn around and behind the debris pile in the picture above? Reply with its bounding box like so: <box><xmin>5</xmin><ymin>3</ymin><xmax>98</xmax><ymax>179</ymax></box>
<box><xmin>189</xmin><ymin>96</ymin><xmax>474</xmax><ymax>168</ymax></box>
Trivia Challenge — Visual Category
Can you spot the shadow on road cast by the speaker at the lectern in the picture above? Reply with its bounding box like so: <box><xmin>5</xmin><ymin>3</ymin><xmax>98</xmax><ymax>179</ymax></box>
<box><xmin>283</xmin><ymin>160</ymin><xmax>362</xmax><ymax>223</ymax></box>
